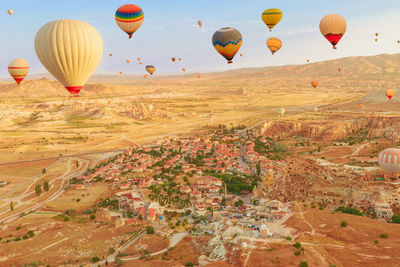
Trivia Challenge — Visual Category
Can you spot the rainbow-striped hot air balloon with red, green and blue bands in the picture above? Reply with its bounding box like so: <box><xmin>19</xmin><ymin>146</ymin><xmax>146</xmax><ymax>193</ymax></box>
<box><xmin>115</xmin><ymin>4</ymin><xmax>144</xmax><ymax>39</ymax></box>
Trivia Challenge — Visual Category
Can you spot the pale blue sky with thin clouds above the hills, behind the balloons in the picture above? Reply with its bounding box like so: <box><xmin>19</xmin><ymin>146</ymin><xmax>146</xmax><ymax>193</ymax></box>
<box><xmin>0</xmin><ymin>0</ymin><xmax>400</xmax><ymax>77</ymax></box>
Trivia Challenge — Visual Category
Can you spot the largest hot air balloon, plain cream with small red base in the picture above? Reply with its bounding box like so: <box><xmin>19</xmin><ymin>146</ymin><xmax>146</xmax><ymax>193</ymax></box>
<box><xmin>35</xmin><ymin>19</ymin><xmax>103</xmax><ymax>95</ymax></box>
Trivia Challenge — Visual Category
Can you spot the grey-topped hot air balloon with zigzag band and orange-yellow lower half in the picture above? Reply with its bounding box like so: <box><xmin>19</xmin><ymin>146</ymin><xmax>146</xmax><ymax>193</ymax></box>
<box><xmin>212</xmin><ymin>27</ymin><xmax>242</xmax><ymax>64</ymax></box>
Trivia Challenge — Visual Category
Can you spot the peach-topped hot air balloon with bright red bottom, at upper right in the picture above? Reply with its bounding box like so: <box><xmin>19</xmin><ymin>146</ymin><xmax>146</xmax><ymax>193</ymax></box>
<box><xmin>319</xmin><ymin>14</ymin><xmax>347</xmax><ymax>49</ymax></box>
